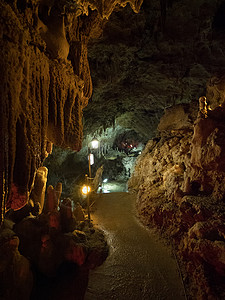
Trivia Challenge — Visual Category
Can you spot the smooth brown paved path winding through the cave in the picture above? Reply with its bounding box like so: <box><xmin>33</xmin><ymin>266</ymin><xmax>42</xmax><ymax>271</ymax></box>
<box><xmin>84</xmin><ymin>192</ymin><xmax>185</xmax><ymax>300</ymax></box>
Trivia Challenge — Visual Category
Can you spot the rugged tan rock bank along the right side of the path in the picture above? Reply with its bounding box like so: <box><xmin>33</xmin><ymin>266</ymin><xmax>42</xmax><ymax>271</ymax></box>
<box><xmin>129</xmin><ymin>82</ymin><xmax>225</xmax><ymax>299</ymax></box>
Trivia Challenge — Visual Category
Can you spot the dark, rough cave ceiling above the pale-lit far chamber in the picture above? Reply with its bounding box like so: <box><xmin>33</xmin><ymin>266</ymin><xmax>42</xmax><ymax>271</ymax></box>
<box><xmin>84</xmin><ymin>0</ymin><xmax>225</xmax><ymax>139</ymax></box>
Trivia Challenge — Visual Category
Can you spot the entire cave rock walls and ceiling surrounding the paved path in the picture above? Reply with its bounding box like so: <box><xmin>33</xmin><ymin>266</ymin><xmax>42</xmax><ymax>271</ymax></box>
<box><xmin>0</xmin><ymin>0</ymin><xmax>225</xmax><ymax>300</ymax></box>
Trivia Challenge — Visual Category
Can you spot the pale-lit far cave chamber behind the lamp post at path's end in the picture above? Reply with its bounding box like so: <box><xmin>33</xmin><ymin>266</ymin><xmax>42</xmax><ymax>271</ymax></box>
<box><xmin>44</xmin><ymin>125</ymin><xmax>146</xmax><ymax>204</ymax></box>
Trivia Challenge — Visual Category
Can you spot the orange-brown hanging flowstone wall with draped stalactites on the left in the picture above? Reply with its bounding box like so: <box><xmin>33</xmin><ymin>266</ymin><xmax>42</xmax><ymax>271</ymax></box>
<box><xmin>0</xmin><ymin>0</ymin><xmax>142</xmax><ymax>216</ymax></box>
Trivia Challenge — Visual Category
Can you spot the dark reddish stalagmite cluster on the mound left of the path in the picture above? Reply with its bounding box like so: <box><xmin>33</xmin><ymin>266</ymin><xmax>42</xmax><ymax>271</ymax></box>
<box><xmin>0</xmin><ymin>167</ymin><xmax>108</xmax><ymax>300</ymax></box>
